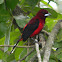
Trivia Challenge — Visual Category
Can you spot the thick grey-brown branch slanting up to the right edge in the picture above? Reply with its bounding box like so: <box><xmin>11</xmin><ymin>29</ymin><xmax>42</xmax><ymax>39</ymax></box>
<box><xmin>43</xmin><ymin>20</ymin><xmax>62</xmax><ymax>62</ymax></box>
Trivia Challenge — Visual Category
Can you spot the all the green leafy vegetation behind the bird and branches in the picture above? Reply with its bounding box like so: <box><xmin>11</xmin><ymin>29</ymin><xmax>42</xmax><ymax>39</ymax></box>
<box><xmin>0</xmin><ymin>0</ymin><xmax>62</xmax><ymax>62</ymax></box>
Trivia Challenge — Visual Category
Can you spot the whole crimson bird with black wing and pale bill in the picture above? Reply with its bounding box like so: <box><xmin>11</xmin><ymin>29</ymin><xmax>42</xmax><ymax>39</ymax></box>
<box><xmin>11</xmin><ymin>9</ymin><xmax>51</xmax><ymax>53</ymax></box>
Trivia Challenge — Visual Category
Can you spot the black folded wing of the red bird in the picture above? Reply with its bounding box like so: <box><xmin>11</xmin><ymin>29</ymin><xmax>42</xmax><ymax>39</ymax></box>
<box><xmin>22</xmin><ymin>19</ymin><xmax>39</xmax><ymax>41</ymax></box>
